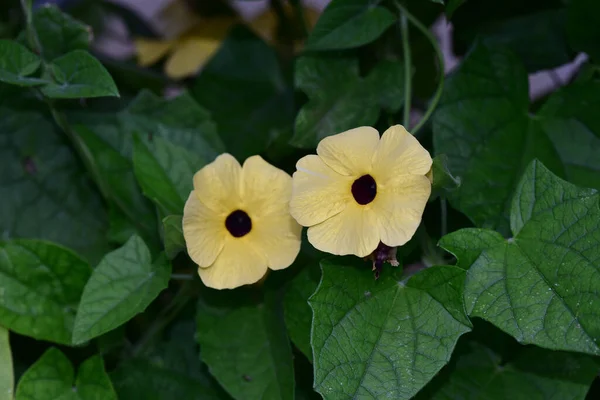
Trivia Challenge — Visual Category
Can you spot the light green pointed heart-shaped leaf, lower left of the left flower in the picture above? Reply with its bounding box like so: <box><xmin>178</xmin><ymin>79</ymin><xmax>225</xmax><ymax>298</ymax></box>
<box><xmin>73</xmin><ymin>236</ymin><xmax>171</xmax><ymax>344</ymax></box>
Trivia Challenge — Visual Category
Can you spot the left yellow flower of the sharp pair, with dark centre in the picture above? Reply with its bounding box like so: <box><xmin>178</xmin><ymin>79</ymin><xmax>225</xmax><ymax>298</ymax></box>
<box><xmin>183</xmin><ymin>154</ymin><xmax>302</xmax><ymax>289</ymax></box>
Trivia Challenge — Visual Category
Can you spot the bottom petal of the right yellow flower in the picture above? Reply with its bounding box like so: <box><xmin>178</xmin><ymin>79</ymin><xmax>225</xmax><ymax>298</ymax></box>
<box><xmin>308</xmin><ymin>204</ymin><xmax>379</xmax><ymax>257</ymax></box>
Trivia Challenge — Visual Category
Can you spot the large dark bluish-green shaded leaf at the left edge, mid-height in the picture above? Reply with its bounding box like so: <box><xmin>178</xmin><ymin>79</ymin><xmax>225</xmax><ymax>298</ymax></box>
<box><xmin>0</xmin><ymin>107</ymin><xmax>108</xmax><ymax>262</ymax></box>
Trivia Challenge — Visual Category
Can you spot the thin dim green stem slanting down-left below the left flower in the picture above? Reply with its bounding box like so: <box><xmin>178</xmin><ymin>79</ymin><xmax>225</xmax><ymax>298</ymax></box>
<box><xmin>131</xmin><ymin>281</ymin><xmax>194</xmax><ymax>357</ymax></box>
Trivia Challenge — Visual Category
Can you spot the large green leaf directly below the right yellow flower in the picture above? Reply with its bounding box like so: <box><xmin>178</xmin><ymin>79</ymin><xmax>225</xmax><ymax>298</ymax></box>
<box><xmin>309</xmin><ymin>258</ymin><xmax>471</xmax><ymax>399</ymax></box>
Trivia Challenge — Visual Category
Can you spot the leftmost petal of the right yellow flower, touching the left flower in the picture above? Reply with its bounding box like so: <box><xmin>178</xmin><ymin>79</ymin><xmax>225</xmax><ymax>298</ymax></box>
<box><xmin>290</xmin><ymin>154</ymin><xmax>354</xmax><ymax>226</ymax></box>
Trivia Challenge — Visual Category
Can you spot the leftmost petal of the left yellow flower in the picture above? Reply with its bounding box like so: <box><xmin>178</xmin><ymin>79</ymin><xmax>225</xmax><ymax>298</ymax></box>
<box><xmin>183</xmin><ymin>190</ymin><xmax>228</xmax><ymax>268</ymax></box>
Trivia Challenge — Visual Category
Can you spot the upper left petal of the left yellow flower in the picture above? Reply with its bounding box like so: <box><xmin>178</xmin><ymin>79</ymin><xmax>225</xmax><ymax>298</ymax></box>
<box><xmin>194</xmin><ymin>153</ymin><xmax>242</xmax><ymax>214</ymax></box>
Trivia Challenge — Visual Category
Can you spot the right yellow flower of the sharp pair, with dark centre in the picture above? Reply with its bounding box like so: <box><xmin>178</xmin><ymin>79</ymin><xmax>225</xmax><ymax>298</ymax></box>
<box><xmin>290</xmin><ymin>125</ymin><xmax>432</xmax><ymax>257</ymax></box>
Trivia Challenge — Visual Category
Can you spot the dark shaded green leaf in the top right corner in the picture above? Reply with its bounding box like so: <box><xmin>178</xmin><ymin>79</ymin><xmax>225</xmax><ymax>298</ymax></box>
<box><xmin>567</xmin><ymin>0</ymin><xmax>600</xmax><ymax>61</ymax></box>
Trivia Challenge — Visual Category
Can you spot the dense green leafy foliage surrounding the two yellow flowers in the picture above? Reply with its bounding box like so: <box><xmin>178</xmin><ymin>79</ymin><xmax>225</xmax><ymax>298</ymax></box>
<box><xmin>0</xmin><ymin>0</ymin><xmax>600</xmax><ymax>400</ymax></box>
